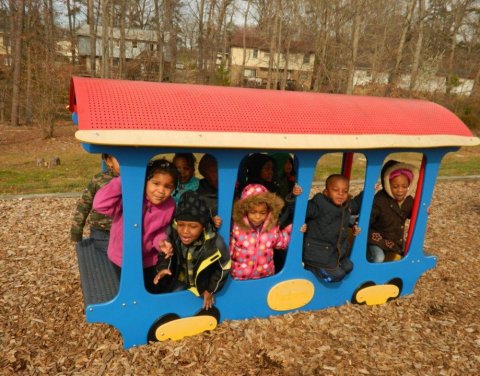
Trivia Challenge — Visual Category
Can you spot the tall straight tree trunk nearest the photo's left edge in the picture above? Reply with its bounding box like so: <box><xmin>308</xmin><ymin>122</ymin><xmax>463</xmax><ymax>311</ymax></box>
<box><xmin>10</xmin><ymin>0</ymin><xmax>24</xmax><ymax>127</ymax></box>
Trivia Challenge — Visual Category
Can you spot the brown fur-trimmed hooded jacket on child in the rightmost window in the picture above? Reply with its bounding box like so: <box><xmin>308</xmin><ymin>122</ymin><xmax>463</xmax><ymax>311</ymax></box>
<box><xmin>368</xmin><ymin>160</ymin><xmax>419</xmax><ymax>255</ymax></box>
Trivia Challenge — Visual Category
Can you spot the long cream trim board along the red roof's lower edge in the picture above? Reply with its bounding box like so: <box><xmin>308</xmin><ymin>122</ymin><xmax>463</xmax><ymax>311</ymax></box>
<box><xmin>75</xmin><ymin>129</ymin><xmax>480</xmax><ymax>150</ymax></box>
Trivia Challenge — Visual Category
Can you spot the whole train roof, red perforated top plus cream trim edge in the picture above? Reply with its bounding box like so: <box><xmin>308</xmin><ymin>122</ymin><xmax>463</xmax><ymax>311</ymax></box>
<box><xmin>70</xmin><ymin>77</ymin><xmax>480</xmax><ymax>149</ymax></box>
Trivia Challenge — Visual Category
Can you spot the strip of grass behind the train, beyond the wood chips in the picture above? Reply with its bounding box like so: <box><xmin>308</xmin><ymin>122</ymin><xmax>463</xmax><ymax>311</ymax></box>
<box><xmin>0</xmin><ymin>140</ymin><xmax>480</xmax><ymax>195</ymax></box>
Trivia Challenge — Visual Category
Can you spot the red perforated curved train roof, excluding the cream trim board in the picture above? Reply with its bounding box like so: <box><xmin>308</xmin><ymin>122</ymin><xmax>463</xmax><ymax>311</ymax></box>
<box><xmin>70</xmin><ymin>77</ymin><xmax>472</xmax><ymax>137</ymax></box>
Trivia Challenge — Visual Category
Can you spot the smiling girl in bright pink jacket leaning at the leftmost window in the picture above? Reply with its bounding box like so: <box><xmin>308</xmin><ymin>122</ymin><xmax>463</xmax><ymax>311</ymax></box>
<box><xmin>93</xmin><ymin>159</ymin><xmax>178</xmax><ymax>292</ymax></box>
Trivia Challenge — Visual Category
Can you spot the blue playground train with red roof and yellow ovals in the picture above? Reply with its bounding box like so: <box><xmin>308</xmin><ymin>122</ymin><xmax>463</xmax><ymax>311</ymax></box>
<box><xmin>69</xmin><ymin>77</ymin><xmax>479</xmax><ymax>348</ymax></box>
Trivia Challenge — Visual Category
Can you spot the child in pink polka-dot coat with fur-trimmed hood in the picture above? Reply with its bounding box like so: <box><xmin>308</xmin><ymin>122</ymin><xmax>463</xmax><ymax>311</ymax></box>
<box><xmin>230</xmin><ymin>184</ymin><xmax>292</xmax><ymax>280</ymax></box>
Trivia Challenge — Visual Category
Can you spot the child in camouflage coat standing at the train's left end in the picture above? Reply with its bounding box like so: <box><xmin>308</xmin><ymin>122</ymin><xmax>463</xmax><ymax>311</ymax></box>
<box><xmin>70</xmin><ymin>153</ymin><xmax>120</xmax><ymax>253</ymax></box>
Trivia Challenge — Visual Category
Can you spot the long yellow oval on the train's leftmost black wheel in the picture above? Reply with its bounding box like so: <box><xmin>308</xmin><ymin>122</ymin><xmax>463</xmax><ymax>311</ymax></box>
<box><xmin>155</xmin><ymin>316</ymin><xmax>217</xmax><ymax>341</ymax></box>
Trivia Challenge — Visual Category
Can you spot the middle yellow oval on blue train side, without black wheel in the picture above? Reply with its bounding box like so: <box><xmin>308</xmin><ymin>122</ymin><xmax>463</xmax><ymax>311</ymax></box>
<box><xmin>267</xmin><ymin>279</ymin><xmax>315</xmax><ymax>311</ymax></box>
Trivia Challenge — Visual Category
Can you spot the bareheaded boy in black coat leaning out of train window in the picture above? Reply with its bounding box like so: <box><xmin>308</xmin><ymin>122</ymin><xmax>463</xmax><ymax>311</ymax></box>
<box><xmin>303</xmin><ymin>174</ymin><xmax>361</xmax><ymax>282</ymax></box>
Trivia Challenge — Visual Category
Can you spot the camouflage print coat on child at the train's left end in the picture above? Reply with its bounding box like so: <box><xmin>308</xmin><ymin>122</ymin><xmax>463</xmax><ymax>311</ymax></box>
<box><xmin>70</xmin><ymin>171</ymin><xmax>113</xmax><ymax>242</ymax></box>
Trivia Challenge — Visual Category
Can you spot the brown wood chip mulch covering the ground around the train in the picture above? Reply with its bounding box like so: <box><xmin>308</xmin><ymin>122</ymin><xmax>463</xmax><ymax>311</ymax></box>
<box><xmin>0</xmin><ymin>180</ymin><xmax>480</xmax><ymax>376</ymax></box>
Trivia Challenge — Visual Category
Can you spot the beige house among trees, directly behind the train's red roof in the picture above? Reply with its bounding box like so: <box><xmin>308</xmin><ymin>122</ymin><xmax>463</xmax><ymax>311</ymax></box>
<box><xmin>229</xmin><ymin>32</ymin><xmax>315</xmax><ymax>90</ymax></box>
